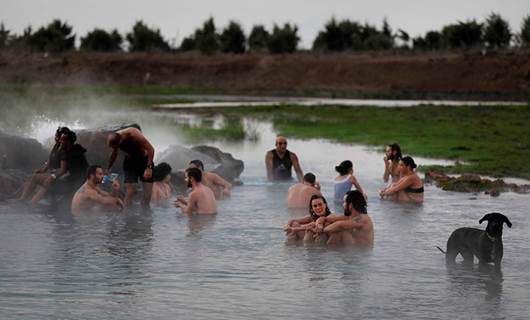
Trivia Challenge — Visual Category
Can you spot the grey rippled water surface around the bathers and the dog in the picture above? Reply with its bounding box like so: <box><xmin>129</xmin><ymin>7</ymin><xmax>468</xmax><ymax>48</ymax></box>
<box><xmin>0</xmin><ymin>109</ymin><xmax>530</xmax><ymax>319</ymax></box>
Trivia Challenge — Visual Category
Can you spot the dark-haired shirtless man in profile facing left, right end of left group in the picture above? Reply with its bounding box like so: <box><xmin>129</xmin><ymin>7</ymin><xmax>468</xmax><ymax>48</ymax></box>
<box><xmin>175</xmin><ymin>168</ymin><xmax>217</xmax><ymax>214</ymax></box>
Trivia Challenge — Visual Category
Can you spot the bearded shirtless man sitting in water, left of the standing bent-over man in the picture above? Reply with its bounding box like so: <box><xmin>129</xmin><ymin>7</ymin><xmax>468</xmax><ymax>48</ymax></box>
<box><xmin>71</xmin><ymin>165</ymin><xmax>123</xmax><ymax>214</ymax></box>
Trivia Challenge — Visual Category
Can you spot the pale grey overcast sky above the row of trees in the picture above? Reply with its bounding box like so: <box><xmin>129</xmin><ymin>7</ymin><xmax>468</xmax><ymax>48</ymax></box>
<box><xmin>0</xmin><ymin>0</ymin><xmax>530</xmax><ymax>48</ymax></box>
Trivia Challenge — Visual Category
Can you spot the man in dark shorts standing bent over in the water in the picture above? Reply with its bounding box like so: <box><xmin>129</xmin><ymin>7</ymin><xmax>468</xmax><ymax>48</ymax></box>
<box><xmin>107</xmin><ymin>127</ymin><xmax>155</xmax><ymax>209</ymax></box>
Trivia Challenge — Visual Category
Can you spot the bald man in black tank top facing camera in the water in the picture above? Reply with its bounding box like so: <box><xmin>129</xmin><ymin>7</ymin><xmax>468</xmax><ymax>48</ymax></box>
<box><xmin>265</xmin><ymin>136</ymin><xmax>304</xmax><ymax>182</ymax></box>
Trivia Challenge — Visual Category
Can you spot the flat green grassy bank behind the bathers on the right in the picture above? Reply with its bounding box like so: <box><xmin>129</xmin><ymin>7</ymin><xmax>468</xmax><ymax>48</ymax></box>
<box><xmin>185</xmin><ymin>105</ymin><xmax>530</xmax><ymax>179</ymax></box>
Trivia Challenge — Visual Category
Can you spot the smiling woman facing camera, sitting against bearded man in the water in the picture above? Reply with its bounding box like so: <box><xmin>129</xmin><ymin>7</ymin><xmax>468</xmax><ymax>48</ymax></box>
<box><xmin>283</xmin><ymin>194</ymin><xmax>331</xmax><ymax>241</ymax></box>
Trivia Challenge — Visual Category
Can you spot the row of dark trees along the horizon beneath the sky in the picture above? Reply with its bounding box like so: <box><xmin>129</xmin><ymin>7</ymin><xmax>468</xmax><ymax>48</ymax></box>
<box><xmin>0</xmin><ymin>13</ymin><xmax>530</xmax><ymax>55</ymax></box>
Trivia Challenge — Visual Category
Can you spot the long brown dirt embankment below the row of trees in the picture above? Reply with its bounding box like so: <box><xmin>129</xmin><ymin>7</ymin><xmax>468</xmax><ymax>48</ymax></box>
<box><xmin>0</xmin><ymin>50</ymin><xmax>530</xmax><ymax>100</ymax></box>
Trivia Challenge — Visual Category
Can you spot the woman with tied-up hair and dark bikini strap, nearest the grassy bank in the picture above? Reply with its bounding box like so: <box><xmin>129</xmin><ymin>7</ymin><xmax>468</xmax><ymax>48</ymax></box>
<box><xmin>379</xmin><ymin>157</ymin><xmax>424</xmax><ymax>203</ymax></box>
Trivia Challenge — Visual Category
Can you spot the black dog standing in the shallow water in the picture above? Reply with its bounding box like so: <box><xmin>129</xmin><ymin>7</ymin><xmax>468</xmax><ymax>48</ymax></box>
<box><xmin>438</xmin><ymin>212</ymin><xmax>512</xmax><ymax>269</ymax></box>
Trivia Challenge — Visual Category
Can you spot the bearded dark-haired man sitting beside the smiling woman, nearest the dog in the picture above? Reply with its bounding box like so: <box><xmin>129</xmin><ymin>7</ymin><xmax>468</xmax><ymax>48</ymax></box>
<box><xmin>316</xmin><ymin>190</ymin><xmax>374</xmax><ymax>247</ymax></box>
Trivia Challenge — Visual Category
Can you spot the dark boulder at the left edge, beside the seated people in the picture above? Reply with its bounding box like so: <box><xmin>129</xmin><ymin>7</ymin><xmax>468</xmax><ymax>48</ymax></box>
<box><xmin>0</xmin><ymin>131</ymin><xmax>49</xmax><ymax>173</ymax></box>
